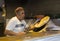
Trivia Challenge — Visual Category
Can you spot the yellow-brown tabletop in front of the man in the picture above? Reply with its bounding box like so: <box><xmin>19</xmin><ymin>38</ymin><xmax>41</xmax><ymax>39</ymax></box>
<box><xmin>0</xmin><ymin>31</ymin><xmax>60</xmax><ymax>41</ymax></box>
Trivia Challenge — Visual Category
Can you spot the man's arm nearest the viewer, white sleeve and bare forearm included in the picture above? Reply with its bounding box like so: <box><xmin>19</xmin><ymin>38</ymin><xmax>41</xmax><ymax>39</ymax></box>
<box><xmin>5</xmin><ymin>20</ymin><xmax>25</xmax><ymax>36</ymax></box>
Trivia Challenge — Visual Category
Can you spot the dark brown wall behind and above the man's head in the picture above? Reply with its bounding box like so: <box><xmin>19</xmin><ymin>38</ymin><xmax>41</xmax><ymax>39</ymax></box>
<box><xmin>5</xmin><ymin>0</ymin><xmax>60</xmax><ymax>18</ymax></box>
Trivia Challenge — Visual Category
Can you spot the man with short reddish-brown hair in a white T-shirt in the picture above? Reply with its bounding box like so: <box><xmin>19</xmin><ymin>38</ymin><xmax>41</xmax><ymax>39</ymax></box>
<box><xmin>5</xmin><ymin>7</ymin><xmax>27</xmax><ymax>36</ymax></box>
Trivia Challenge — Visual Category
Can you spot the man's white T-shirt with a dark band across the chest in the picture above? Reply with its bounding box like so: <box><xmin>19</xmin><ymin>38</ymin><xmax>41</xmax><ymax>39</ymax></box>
<box><xmin>6</xmin><ymin>16</ymin><xmax>27</xmax><ymax>33</ymax></box>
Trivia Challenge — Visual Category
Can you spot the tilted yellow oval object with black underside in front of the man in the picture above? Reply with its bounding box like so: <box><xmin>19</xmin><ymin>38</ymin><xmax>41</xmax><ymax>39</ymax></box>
<box><xmin>29</xmin><ymin>16</ymin><xmax>50</xmax><ymax>32</ymax></box>
